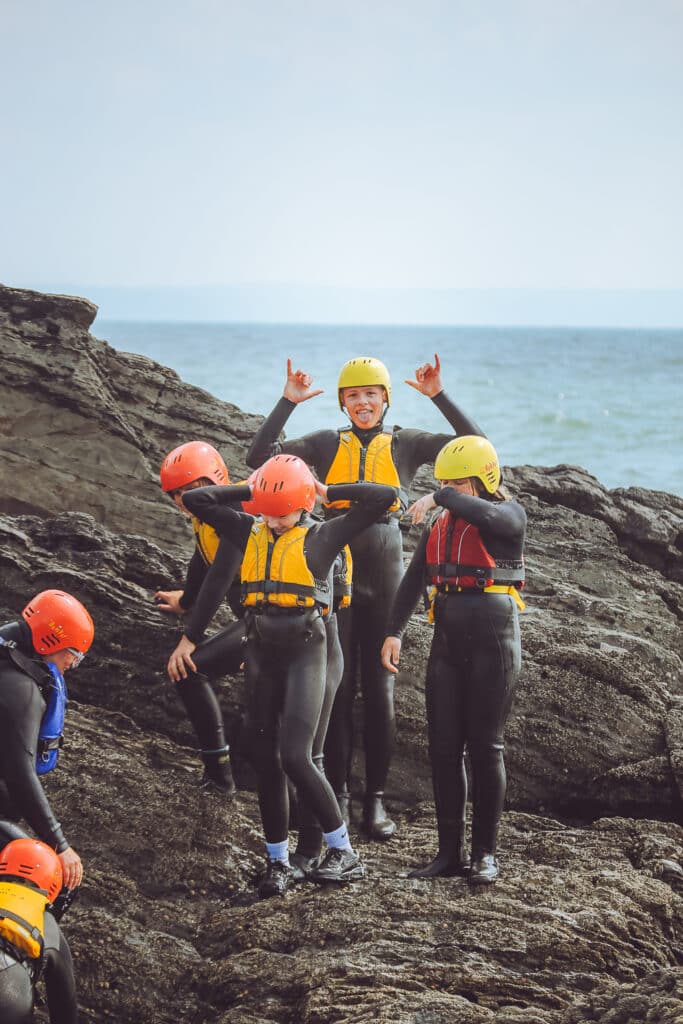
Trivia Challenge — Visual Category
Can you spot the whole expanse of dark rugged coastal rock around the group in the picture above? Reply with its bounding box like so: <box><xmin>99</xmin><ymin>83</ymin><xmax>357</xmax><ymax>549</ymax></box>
<box><xmin>0</xmin><ymin>289</ymin><xmax>683</xmax><ymax>1024</ymax></box>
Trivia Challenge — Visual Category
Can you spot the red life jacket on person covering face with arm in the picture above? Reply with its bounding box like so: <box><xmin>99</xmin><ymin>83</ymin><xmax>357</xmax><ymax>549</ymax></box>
<box><xmin>426</xmin><ymin>509</ymin><xmax>524</xmax><ymax>590</ymax></box>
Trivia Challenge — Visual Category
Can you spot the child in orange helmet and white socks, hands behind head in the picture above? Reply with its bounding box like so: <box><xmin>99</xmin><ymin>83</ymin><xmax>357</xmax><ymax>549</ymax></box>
<box><xmin>184</xmin><ymin>455</ymin><xmax>396</xmax><ymax>896</ymax></box>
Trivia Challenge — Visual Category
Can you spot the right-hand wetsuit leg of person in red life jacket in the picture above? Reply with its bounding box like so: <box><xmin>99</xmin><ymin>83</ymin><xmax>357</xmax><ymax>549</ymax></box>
<box><xmin>466</xmin><ymin>594</ymin><xmax>521</xmax><ymax>856</ymax></box>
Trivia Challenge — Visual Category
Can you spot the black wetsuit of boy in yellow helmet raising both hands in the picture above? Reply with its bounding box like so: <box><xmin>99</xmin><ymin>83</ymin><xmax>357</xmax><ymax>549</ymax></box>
<box><xmin>247</xmin><ymin>391</ymin><xmax>481</xmax><ymax>794</ymax></box>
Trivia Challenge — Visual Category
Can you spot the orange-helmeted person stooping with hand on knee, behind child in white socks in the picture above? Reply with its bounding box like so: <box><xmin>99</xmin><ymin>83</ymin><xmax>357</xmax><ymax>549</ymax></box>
<box><xmin>155</xmin><ymin>441</ymin><xmax>249</xmax><ymax>799</ymax></box>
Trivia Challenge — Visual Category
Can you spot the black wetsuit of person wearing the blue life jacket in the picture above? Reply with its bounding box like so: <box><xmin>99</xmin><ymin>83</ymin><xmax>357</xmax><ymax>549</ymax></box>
<box><xmin>0</xmin><ymin>621</ymin><xmax>69</xmax><ymax>853</ymax></box>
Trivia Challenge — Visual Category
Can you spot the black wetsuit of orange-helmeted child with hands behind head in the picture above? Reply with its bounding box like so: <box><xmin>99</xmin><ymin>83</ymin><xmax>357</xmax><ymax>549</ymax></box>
<box><xmin>183</xmin><ymin>483</ymin><xmax>396</xmax><ymax>843</ymax></box>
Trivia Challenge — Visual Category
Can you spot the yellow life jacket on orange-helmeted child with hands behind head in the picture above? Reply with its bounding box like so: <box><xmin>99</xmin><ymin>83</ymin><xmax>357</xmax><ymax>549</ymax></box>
<box><xmin>242</xmin><ymin>521</ymin><xmax>332</xmax><ymax>611</ymax></box>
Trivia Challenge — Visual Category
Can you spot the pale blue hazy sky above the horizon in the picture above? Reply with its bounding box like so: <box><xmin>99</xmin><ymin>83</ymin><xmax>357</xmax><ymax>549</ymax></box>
<box><xmin>0</xmin><ymin>0</ymin><xmax>683</xmax><ymax>319</ymax></box>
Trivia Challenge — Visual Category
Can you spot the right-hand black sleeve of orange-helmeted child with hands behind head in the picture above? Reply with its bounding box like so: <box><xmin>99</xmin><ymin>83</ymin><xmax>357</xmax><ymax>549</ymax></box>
<box><xmin>306</xmin><ymin>482</ymin><xmax>396</xmax><ymax>579</ymax></box>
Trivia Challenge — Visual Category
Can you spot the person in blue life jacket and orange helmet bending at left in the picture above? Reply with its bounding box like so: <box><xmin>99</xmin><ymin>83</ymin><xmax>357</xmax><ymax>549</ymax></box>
<box><xmin>0</xmin><ymin>590</ymin><xmax>94</xmax><ymax>889</ymax></box>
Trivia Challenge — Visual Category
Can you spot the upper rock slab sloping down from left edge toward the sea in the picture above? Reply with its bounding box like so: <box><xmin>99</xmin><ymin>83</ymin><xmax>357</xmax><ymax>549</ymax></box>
<box><xmin>0</xmin><ymin>287</ymin><xmax>256</xmax><ymax>546</ymax></box>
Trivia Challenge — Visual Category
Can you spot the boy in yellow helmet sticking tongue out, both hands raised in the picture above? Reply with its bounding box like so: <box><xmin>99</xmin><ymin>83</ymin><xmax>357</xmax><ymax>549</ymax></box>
<box><xmin>247</xmin><ymin>355</ymin><xmax>480</xmax><ymax>840</ymax></box>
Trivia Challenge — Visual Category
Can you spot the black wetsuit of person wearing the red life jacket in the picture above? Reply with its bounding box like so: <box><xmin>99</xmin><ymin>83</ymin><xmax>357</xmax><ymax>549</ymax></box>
<box><xmin>387</xmin><ymin>487</ymin><xmax>526</xmax><ymax>858</ymax></box>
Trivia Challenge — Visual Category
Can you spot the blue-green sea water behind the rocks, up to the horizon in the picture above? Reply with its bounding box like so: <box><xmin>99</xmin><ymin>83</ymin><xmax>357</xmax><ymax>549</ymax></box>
<box><xmin>92</xmin><ymin>319</ymin><xmax>683</xmax><ymax>496</ymax></box>
